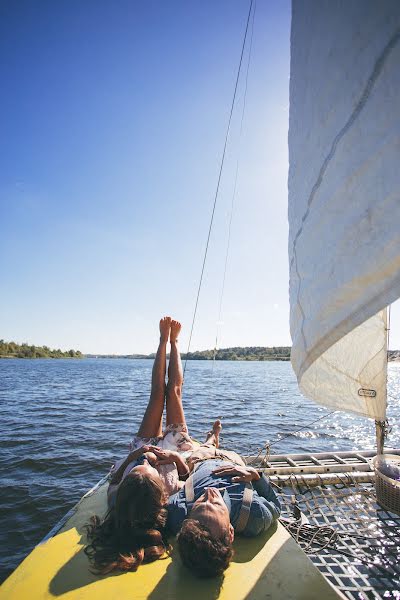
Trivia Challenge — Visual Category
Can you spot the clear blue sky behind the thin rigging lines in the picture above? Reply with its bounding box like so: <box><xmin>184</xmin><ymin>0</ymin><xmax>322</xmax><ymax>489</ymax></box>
<box><xmin>0</xmin><ymin>0</ymin><xmax>398</xmax><ymax>353</ymax></box>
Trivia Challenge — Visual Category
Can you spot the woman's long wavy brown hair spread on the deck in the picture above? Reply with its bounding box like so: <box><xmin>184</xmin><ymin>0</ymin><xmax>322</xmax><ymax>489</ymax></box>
<box><xmin>85</xmin><ymin>472</ymin><xmax>169</xmax><ymax>575</ymax></box>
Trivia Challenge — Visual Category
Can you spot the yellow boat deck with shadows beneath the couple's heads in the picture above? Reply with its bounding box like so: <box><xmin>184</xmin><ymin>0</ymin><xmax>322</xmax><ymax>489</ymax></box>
<box><xmin>0</xmin><ymin>483</ymin><xmax>344</xmax><ymax>600</ymax></box>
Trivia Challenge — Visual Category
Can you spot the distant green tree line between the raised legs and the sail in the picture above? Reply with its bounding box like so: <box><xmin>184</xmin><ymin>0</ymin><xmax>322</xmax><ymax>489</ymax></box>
<box><xmin>182</xmin><ymin>346</ymin><xmax>290</xmax><ymax>360</ymax></box>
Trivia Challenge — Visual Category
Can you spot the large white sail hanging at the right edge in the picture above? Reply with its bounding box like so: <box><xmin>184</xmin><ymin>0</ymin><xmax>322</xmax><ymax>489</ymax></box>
<box><xmin>289</xmin><ymin>0</ymin><xmax>400</xmax><ymax>420</ymax></box>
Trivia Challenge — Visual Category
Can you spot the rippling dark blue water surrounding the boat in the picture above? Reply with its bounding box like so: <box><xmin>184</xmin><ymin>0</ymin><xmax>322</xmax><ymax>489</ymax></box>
<box><xmin>0</xmin><ymin>359</ymin><xmax>400</xmax><ymax>580</ymax></box>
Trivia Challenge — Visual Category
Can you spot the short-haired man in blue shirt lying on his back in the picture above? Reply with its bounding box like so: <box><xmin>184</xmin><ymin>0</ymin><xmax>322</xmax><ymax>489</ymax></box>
<box><xmin>147</xmin><ymin>420</ymin><xmax>280</xmax><ymax>577</ymax></box>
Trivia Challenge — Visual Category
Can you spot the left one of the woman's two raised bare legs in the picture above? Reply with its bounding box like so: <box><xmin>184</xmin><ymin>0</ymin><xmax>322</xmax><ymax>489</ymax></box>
<box><xmin>138</xmin><ymin>317</ymin><xmax>171</xmax><ymax>438</ymax></box>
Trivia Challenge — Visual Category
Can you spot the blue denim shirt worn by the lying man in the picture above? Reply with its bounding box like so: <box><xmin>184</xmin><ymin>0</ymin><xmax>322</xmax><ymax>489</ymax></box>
<box><xmin>168</xmin><ymin>460</ymin><xmax>281</xmax><ymax>537</ymax></box>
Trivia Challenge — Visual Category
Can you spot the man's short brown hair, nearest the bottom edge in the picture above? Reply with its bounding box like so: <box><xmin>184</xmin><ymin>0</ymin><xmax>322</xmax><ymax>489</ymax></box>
<box><xmin>177</xmin><ymin>519</ymin><xmax>233</xmax><ymax>577</ymax></box>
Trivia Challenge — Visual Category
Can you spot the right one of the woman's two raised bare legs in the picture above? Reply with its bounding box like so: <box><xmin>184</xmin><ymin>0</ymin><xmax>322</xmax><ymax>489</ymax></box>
<box><xmin>167</xmin><ymin>320</ymin><xmax>186</xmax><ymax>425</ymax></box>
